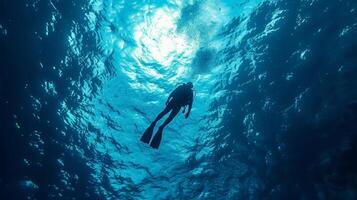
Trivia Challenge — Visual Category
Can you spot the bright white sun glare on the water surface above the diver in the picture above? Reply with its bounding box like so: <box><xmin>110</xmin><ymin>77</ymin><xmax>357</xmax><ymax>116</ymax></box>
<box><xmin>134</xmin><ymin>8</ymin><xmax>194</xmax><ymax>75</ymax></box>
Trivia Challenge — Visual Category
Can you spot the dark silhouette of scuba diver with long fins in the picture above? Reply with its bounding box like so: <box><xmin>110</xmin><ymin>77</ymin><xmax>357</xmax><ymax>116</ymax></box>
<box><xmin>140</xmin><ymin>82</ymin><xmax>193</xmax><ymax>149</ymax></box>
